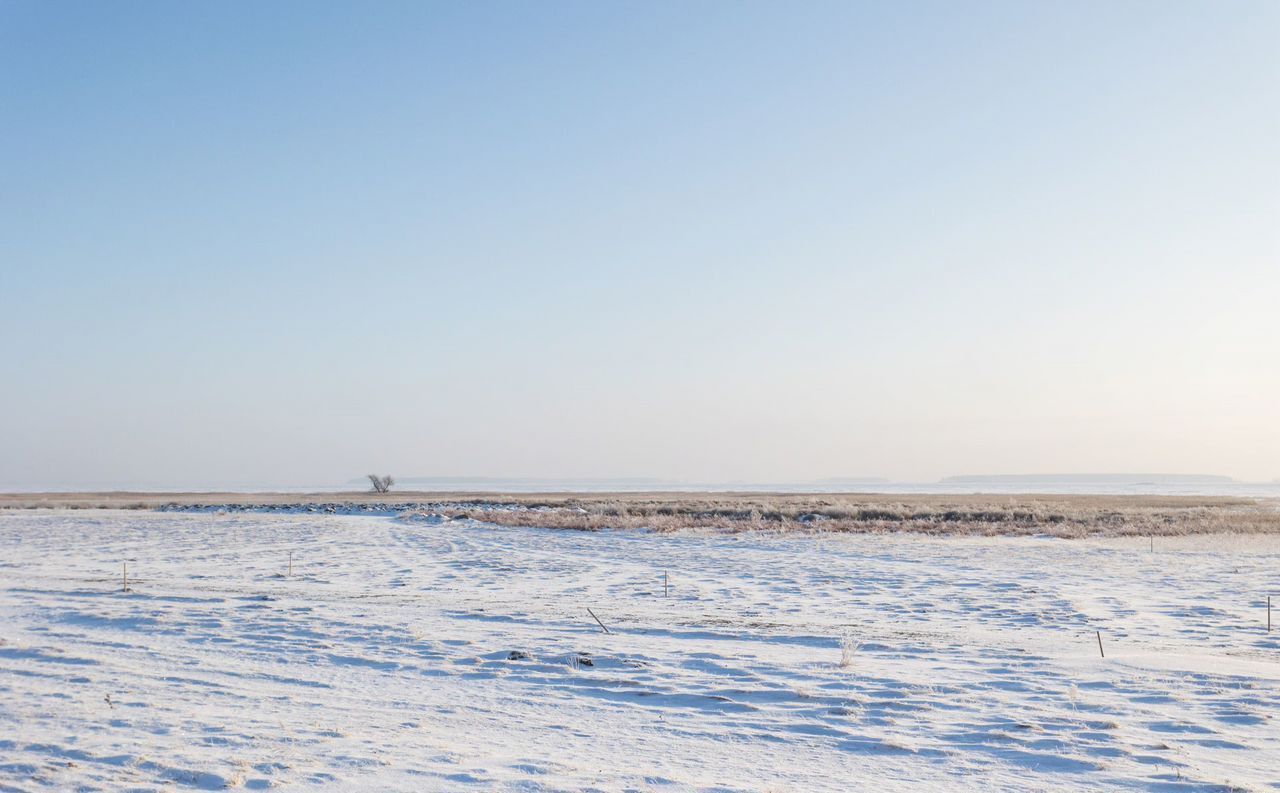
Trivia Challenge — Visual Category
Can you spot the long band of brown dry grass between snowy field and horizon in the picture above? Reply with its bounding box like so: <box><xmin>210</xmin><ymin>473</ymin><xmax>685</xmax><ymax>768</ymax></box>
<box><xmin>0</xmin><ymin>491</ymin><xmax>1280</xmax><ymax>537</ymax></box>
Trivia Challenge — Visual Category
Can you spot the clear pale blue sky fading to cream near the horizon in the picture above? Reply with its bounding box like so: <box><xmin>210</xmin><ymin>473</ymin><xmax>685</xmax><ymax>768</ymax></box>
<box><xmin>0</xmin><ymin>0</ymin><xmax>1280</xmax><ymax>490</ymax></box>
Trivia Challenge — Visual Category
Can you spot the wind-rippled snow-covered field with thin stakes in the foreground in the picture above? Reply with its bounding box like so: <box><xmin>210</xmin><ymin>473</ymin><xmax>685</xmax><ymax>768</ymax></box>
<box><xmin>0</xmin><ymin>512</ymin><xmax>1280</xmax><ymax>790</ymax></box>
